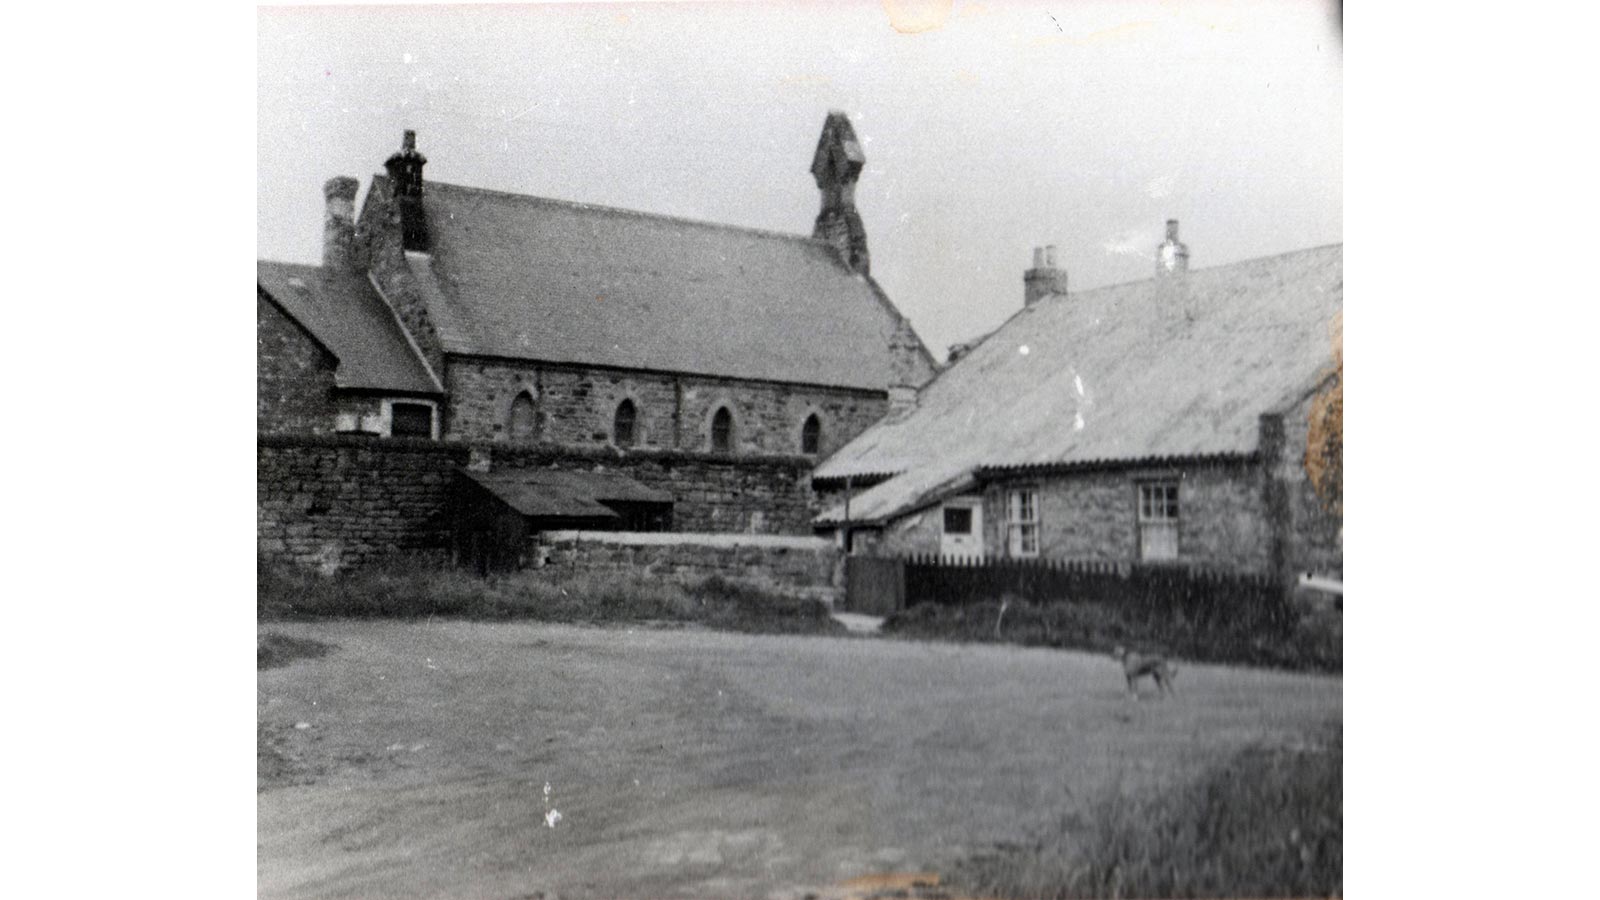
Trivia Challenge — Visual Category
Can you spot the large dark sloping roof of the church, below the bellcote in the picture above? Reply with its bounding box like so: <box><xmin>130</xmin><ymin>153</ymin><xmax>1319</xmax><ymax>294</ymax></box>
<box><xmin>371</xmin><ymin>176</ymin><xmax>931</xmax><ymax>391</ymax></box>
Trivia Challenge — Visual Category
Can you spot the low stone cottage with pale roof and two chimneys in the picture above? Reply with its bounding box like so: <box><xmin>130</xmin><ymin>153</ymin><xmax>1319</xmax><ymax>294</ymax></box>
<box><xmin>813</xmin><ymin>223</ymin><xmax>1344</xmax><ymax>578</ymax></box>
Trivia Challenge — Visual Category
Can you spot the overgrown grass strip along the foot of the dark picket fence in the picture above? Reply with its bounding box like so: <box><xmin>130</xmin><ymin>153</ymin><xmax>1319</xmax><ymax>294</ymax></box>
<box><xmin>882</xmin><ymin>599</ymin><xmax>1344</xmax><ymax>673</ymax></box>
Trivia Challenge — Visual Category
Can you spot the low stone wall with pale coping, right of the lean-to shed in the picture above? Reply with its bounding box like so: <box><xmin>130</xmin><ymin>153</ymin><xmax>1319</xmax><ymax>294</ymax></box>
<box><xmin>544</xmin><ymin>532</ymin><xmax>845</xmax><ymax>604</ymax></box>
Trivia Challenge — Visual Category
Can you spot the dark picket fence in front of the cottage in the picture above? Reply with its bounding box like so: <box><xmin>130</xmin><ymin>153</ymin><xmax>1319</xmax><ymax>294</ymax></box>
<box><xmin>901</xmin><ymin>556</ymin><xmax>1294</xmax><ymax>629</ymax></box>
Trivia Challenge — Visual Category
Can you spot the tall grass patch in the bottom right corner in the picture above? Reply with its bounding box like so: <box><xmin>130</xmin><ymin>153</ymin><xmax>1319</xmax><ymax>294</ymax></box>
<box><xmin>955</xmin><ymin>732</ymin><xmax>1344</xmax><ymax>900</ymax></box>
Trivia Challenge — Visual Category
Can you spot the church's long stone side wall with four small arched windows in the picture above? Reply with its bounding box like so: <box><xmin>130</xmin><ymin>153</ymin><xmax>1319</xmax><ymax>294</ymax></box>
<box><xmin>445</xmin><ymin>357</ymin><xmax>888</xmax><ymax>460</ymax></box>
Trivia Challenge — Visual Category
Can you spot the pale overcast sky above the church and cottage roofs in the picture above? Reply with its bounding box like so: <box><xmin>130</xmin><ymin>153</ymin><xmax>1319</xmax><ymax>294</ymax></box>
<box><xmin>256</xmin><ymin>0</ymin><xmax>1342</xmax><ymax>359</ymax></box>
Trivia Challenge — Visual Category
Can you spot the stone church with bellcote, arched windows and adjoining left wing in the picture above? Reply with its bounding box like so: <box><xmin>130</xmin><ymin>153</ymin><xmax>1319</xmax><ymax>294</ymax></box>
<box><xmin>256</xmin><ymin>112</ymin><xmax>936</xmax><ymax>460</ymax></box>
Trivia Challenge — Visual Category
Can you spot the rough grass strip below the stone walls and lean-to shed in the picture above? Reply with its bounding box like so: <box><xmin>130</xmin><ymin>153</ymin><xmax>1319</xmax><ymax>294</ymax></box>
<box><xmin>256</xmin><ymin>562</ymin><xmax>845</xmax><ymax>634</ymax></box>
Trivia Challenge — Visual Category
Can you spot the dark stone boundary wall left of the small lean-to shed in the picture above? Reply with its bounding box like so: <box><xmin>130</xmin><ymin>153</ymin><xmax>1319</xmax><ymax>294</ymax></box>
<box><xmin>256</xmin><ymin>436</ymin><xmax>469</xmax><ymax>572</ymax></box>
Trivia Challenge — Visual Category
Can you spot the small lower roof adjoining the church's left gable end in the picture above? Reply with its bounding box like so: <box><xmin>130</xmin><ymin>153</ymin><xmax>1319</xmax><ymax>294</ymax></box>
<box><xmin>256</xmin><ymin>259</ymin><xmax>443</xmax><ymax>394</ymax></box>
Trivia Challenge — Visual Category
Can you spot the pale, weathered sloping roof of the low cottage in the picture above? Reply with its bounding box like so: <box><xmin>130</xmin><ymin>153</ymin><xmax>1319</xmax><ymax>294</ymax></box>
<box><xmin>814</xmin><ymin>245</ymin><xmax>1344</xmax><ymax>522</ymax></box>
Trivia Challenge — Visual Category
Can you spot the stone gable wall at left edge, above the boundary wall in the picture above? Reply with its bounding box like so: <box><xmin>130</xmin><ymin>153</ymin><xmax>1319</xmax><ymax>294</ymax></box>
<box><xmin>256</xmin><ymin>291</ymin><xmax>336</xmax><ymax>434</ymax></box>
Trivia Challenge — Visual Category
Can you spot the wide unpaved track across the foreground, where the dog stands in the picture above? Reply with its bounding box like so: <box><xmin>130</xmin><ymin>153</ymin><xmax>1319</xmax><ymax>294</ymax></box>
<box><xmin>258</xmin><ymin>621</ymin><xmax>1341</xmax><ymax>898</ymax></box>
